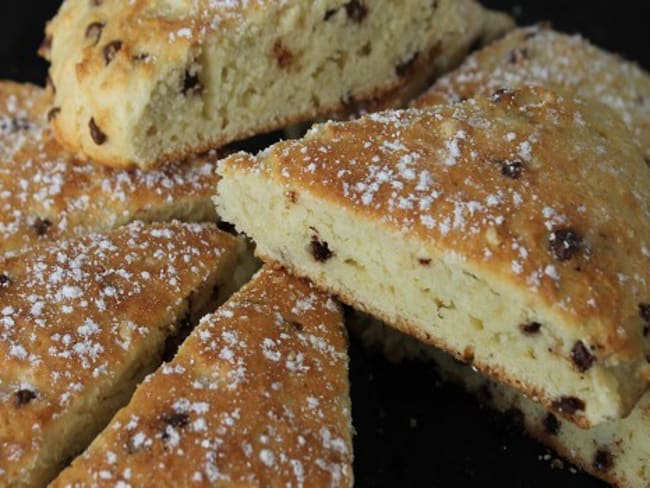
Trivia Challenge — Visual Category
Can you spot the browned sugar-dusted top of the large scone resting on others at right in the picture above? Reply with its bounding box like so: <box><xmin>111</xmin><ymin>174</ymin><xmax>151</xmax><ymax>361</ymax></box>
<box><xmin>220</xmin><ymin>88</ymin><xmax>650</xmax><ymax>362</ymax></box>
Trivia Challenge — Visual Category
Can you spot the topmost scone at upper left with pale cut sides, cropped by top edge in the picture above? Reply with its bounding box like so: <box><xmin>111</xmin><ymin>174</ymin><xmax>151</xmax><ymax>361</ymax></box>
<box><xmin>41</xmin><ymin>0</ymin><xmax>504</xmax><ymax>168</ymax></box>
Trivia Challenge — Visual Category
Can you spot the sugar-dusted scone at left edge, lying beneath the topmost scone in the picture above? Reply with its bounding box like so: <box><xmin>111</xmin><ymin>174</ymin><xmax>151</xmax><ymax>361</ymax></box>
<box><xmin>0</xmin><ymin>81</ymin><xmax>218</xmax><ymax>254</ymax></box>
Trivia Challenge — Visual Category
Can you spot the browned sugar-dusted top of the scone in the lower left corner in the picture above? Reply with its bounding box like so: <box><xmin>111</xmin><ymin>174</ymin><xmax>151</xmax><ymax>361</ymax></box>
<box><xmin>0</xmin><ymin>223</ymin><xmax>236</xmax><ymax>485</ymax></box>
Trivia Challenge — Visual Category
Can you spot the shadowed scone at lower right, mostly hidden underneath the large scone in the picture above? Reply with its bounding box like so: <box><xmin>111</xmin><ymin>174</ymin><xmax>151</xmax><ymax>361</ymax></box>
<box><xmin>353</xmin><ymin>316</ymin><xmax>650</xmax><ymax>488</ymax></box>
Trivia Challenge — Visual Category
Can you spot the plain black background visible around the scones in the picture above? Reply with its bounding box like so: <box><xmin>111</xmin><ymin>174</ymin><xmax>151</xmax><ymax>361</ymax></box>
<box><xmin>0</xmin><ymin>0</ymin><xmax>650</xmax><ymax>488</ymax></box>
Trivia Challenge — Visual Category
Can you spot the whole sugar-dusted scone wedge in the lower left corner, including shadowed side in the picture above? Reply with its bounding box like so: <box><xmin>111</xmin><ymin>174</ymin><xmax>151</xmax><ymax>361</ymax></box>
<box><xmin>0</xmin><ymin>223</ymin><xmax>239</xmax><ymax>486</ymax></box>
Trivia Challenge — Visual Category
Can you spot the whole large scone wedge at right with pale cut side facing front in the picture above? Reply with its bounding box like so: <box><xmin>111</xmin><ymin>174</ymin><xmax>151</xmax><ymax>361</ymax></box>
<box><xmin>215</xmin><ymin>87</ymin><xmax>650</xmax><ymax>427</ymax></box>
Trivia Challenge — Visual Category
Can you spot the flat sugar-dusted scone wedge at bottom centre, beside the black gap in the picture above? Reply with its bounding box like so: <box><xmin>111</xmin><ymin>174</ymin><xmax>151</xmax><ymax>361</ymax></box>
<box><xmin>52</xmin><ymin>269</ymin><xmax>353</xmax><ymax>488</ymax></box>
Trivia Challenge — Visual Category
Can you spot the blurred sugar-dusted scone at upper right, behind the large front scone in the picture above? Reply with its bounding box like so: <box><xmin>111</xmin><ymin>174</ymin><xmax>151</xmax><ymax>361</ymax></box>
<box><xmin>414</xmin><ymin>25</ymin><xmax>650</xmax><ymax>159</ymax></box>
